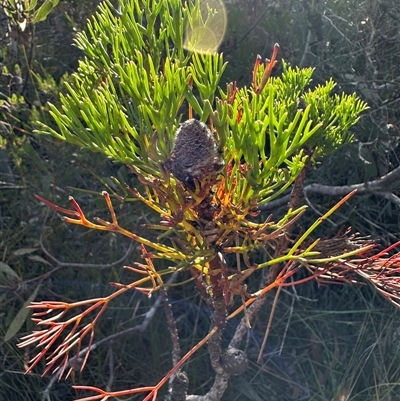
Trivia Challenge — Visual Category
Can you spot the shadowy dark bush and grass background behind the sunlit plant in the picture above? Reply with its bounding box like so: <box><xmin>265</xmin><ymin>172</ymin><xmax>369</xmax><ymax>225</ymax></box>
<box><xmin>0</xmin><ymin>0</ymin><xmax>400</xmax><ymax>401</ymax></box>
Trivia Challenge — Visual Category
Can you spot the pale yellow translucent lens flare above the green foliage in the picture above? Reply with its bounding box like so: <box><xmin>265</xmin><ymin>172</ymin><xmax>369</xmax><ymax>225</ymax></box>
<box><xmin>183</xmin><ymin>0</ymin><xmax>227</xmax><ymax>53</ymax></box>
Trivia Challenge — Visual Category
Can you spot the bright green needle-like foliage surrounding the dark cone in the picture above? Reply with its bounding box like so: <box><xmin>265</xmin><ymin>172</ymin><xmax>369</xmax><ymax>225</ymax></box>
<box><xmin>36</xmin><ymin>0</ymin><xmax>366</xmax><ymax>205</ymax></box>
